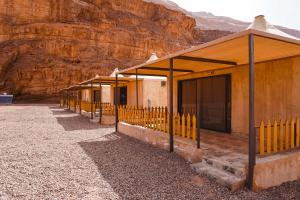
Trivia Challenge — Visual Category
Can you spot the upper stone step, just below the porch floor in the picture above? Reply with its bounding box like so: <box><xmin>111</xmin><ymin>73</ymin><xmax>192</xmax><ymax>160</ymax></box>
<box><xmin>203</xmin><ymin>156</ymin><xmax>247</xmax><ymax>178</ymax></box>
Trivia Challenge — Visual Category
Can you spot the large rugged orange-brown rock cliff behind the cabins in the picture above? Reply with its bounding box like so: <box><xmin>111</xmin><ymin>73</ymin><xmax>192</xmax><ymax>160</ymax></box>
<box><xmin>0</xmin><ymin>0</ymin><xmax>228</xmax><ymax>98</ymax></box>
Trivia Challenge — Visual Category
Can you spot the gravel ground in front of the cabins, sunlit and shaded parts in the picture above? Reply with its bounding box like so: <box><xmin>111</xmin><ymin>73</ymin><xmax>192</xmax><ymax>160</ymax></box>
<box><xmin>0</xmin><ymin>105</ymin><xmax>300</xmax><ymax>200</ymax></box>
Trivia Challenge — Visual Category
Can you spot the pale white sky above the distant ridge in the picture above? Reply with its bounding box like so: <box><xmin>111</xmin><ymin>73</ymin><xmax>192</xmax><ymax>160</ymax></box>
<box><xmin>171</xmin><ymin>0</ymin><xmax>300</xmax><ymax>30</ymax></box>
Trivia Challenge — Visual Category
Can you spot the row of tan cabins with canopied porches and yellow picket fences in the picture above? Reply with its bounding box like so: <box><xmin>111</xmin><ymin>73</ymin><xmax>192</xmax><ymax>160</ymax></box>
<box><xmin>59</xmin><ymin>16</ymin><xmax>300</xmax><ymax>190</ymax></box>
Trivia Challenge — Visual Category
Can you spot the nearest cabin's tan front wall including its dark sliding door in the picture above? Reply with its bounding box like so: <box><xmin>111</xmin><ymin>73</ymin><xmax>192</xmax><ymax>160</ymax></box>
<box><xmin>170</xmin><ymin>56</ymin><xmax>300</xmax><ymax>137</ymax></box>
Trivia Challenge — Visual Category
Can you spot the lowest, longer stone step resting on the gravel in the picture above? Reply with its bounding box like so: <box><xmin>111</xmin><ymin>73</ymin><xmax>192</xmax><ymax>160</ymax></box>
<box><xmin>191</xmin><ymin>162</ymin><xmax>246</xmax><ymax>191</ymax></box>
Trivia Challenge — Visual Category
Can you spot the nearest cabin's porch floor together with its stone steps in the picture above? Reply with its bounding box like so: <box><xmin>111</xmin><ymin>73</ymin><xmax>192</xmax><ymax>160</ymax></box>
<box><xmin>192</xmin><ymin>130</ymin><xmax>248</xmax><ymax>191</ymax></box>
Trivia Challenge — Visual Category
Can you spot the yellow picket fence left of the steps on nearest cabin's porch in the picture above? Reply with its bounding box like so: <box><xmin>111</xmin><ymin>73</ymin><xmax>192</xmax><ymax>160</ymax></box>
<box><xmin>118</xmin><ymin>106</ymin><xmax>196</xmax><ymax>141</ymax></box>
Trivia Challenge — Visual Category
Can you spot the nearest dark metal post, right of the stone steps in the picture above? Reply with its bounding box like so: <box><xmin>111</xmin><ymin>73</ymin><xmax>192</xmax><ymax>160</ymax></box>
<box><xmin>248</xmin><ymin>34</ymin><xmax>256</xmax><ymax>189</ymax></box>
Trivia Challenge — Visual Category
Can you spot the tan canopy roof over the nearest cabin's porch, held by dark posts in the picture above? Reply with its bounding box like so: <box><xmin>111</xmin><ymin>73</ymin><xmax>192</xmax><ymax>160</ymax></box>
<box><xmin>119</xmin><ymin>28</ymin><xmax>300</xmax><ymax>76</ymax></box>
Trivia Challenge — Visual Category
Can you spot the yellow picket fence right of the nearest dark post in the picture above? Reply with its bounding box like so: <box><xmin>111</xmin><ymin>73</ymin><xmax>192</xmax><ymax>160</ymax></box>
<box><xmin>259</xmin><ymin>117</ymin><xmax>300</xmax><ymax>156</ymax></box>
